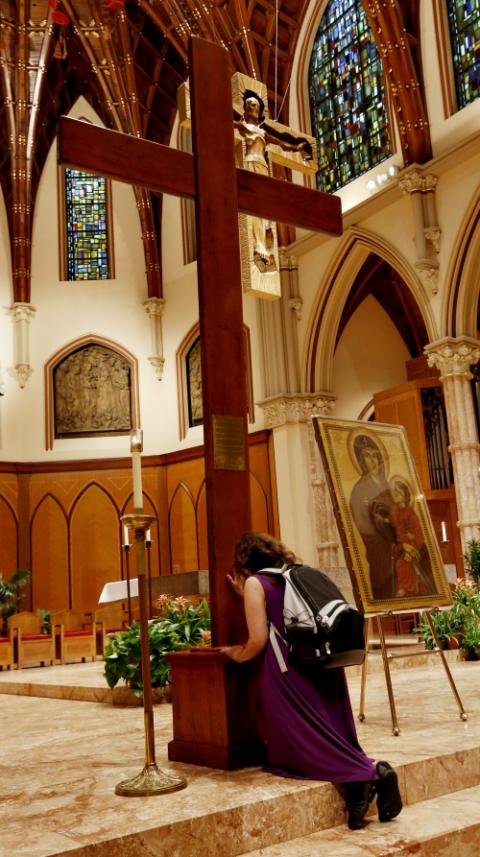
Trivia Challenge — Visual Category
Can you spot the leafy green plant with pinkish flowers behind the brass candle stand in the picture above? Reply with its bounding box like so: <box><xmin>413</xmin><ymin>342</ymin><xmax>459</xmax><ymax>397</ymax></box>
<box><xmin>103</xmin><ymin>595</ymin><xmax>211</xmax><ymax>696</ymax></box>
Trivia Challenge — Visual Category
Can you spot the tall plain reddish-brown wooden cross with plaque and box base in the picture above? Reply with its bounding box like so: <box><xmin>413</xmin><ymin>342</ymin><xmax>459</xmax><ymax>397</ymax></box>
<box><xmin>59</xmin><ymin>38</ymin><xmax>342</xmax><ymax>768</ymax></box>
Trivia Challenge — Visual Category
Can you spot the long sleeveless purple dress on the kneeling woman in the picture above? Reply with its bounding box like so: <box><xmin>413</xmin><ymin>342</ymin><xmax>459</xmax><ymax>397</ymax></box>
<box><xmin>256</xmin><ymin>574</ymin><xmax>378</xmax><ymax>783</ymax></box>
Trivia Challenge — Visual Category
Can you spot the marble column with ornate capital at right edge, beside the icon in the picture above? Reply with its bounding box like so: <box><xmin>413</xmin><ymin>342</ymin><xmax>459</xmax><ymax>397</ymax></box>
<box><xmin>425</xmin><ymin>336</ymin><xmax>480</xmax><ymax>550</ymax></box>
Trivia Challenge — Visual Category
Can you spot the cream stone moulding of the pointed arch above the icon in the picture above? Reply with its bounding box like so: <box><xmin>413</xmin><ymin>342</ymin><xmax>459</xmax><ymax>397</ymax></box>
<box><xmin>302</xmin><ymin>228</ymin><xmax>438</xmax><ymax>392</ymax></box>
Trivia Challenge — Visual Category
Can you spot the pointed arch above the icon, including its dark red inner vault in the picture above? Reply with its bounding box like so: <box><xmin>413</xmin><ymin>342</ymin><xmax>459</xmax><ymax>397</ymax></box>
<box><xmin>305</xmin><ymin>229</ymin><xmax>437</xmax><ymax>392</ymax></box>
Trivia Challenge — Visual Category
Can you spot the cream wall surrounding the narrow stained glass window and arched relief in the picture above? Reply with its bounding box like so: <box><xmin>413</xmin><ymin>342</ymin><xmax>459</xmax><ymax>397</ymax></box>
<box><xmin>0</xmin><ymin>99</ymin><xmax>165</xmax><ymax>461</ymax></box>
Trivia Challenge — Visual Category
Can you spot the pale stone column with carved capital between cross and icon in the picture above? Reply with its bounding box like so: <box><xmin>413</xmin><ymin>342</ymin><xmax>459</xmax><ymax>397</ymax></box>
<box><xmin>259</xmin><ymin>393</ymin><xmax>343</xmax><ymax>568</ymax></box>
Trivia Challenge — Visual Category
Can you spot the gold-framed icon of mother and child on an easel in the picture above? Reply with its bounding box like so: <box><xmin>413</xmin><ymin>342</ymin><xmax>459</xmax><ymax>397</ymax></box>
<box><xmin>313</xmin><ymin>417</ymin><xmax>452</xmax><ymax>614</ymax></box>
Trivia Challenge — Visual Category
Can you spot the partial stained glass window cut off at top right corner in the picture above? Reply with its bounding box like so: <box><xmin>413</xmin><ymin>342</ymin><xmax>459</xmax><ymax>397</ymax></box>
<box><xmin>447</xmin><ymin>0</ymin><xmax>480</xmax><ymax>109</ymax></box>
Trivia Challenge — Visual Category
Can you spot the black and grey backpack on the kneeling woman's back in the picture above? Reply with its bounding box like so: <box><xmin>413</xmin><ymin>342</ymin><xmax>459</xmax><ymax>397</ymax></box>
<box><xmin>258</xmin><ymin>565</ymin><xmax>365</xmax><ymax>672</ymax></box>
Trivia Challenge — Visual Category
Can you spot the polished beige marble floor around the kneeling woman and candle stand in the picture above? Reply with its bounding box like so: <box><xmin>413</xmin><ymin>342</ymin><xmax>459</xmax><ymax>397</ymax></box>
<box><xmin>0</xmin><ymin>658</ymin><xmax>480</xmax><ymax>857</ymax></box>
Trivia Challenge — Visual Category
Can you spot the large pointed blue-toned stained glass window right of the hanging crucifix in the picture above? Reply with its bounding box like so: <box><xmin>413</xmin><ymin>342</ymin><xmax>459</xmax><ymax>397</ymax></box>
<box><xmin>309</xmin><ymin>0</ymin><xmax>392</xmax><ymax>193</ymax></box>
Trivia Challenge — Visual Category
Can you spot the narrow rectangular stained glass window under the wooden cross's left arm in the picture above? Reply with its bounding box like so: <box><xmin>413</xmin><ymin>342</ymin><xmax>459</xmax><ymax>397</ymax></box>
<box><xmin>65</xmin><ymin>168</ymin><xmax>110</xmax><ymax>280</ymax></box>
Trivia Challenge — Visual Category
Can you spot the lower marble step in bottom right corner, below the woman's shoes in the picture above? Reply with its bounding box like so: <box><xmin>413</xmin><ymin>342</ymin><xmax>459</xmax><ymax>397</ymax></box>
<box><xmin>242</xmin><ymin>786</ymin><xmax>480</xmax><ymax>857</ymax></box>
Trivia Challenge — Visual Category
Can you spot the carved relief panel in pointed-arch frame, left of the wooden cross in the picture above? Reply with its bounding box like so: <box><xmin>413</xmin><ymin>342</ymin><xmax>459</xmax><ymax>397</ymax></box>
<box><xmin>44</xmin><ymin>333</ymin><xmax>140</xmax><ymax>449</ymax></box>
